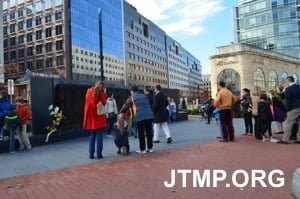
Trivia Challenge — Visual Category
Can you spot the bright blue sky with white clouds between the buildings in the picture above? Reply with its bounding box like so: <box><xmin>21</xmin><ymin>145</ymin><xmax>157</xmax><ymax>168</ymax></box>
<box><xmin>127</xmin><ymin>0</ymin><xmax>236</xmax><ymax>74</ymax></box>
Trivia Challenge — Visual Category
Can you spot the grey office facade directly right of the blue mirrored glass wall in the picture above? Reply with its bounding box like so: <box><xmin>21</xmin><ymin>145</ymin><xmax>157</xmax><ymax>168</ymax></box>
<box><xmin>124</xmin><ymin>1</ymin><xmax>168</xmax><ymax>87</ymax></box>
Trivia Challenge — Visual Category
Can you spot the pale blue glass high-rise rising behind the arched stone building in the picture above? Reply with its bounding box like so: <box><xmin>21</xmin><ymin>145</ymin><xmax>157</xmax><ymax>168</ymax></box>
<box><xmin>234</xmin><ymin>0</ymin><xmax>300</xmax><ymax>58</ymax></box>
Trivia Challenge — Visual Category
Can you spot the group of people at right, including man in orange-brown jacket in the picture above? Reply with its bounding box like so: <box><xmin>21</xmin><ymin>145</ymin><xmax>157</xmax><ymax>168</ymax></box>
<box><xmin>213</xmin><ymin>76</ymin><xmax>300</xmax><ymax>144</ymax></box>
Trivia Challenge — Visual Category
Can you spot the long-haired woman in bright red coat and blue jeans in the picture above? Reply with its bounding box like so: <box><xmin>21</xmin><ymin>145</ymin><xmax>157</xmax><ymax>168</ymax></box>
<box><xmin>83</xmin><ymin>82</ymin><xmax>106</xmax><ymax>159</ymax></box>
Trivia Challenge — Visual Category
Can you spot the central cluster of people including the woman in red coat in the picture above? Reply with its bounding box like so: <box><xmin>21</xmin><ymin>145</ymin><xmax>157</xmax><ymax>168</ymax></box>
<box><xmin>83</xmin><ymin>82</ymin><xmax>176</xmax><ymax>159</ymax></box>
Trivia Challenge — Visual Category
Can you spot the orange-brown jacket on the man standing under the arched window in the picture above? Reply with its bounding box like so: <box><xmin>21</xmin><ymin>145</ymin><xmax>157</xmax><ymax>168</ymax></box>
<box><xmin>214</xmin><ymin>88</ymin><xmax>236</xmax><ymax>110</ymax></box>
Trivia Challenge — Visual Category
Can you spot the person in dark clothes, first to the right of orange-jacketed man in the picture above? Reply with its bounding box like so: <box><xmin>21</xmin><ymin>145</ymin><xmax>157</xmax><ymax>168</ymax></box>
<box><xmin>241</xmin><ymin>88</ymin><xmax>253</xmax><ymax>136</ymax></box>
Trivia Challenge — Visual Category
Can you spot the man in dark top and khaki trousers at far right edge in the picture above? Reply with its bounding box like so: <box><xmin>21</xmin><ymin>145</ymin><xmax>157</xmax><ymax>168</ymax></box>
<box><xmin>278</xmin><ymin>76</ymin><xmax>300</xmax><ymax>144</ymax></box>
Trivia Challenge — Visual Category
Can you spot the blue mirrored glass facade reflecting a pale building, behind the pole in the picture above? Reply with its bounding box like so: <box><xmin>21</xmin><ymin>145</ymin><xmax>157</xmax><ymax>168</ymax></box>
<box><xmin>70</xmin><ymin>0</ymin><xmax>125</xmax><ymax>84</ymax></box>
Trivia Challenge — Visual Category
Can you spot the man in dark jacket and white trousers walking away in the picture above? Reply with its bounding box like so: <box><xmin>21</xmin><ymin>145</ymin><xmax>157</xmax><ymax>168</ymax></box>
<box><xmin>153</xmin><ymin>85</ymin><xmax>172</xmax><ymax>144</ymax></box>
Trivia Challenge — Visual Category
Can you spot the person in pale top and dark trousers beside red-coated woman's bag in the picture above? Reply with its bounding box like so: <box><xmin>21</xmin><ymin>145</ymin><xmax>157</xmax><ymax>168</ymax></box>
<box><xmin>106</xmin><ymin>93</ymin><xmax>118</xmax><ymax>138</ymax></box>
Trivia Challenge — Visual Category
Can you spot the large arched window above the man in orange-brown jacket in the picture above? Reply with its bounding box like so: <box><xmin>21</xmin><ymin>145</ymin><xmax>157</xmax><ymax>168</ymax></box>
<box><xmin>218</xmin><ymin>69</ymin><xmax>241</xmax><ymax>93</ymax></box>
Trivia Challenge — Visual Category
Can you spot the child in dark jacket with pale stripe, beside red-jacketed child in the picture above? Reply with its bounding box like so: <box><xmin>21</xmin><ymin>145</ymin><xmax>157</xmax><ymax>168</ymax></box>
<box><xmin>4</xmin><ymin>104</ymin><xmax>22</xmax><ymax>153</ymax></box>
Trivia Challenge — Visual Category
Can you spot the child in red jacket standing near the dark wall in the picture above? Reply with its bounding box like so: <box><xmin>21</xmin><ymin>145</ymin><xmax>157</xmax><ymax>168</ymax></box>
<box><xmin>16</xmin><ymin>97</ymin><xmax>31</xmax><ymax>151</ymax></box>
